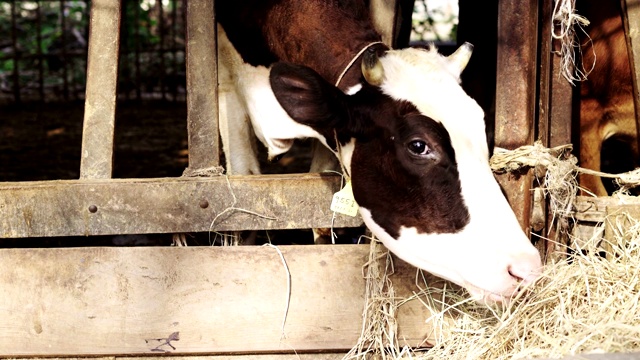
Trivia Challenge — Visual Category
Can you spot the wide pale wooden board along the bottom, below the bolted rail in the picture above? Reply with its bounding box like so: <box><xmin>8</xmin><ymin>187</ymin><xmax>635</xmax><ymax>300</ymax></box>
<box><xmin>0</xmin><ymin>245</ymin><xmax>448</xmax><ymax>357</ymax></box>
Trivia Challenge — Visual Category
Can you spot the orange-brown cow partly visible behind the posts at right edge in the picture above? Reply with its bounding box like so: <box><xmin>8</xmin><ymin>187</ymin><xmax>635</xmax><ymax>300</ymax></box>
<box><xmin>576</xmin><ymin>1</ymin><xmax>640</xmax><ymax>196</ymax></box>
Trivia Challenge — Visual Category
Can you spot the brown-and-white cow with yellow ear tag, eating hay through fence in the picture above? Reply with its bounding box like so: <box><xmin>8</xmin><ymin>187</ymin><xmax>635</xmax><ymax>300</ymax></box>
<box><xmin>216</xmin><ymin>0</ymin><xmax>542</xmax><ymax>303</ymax></box>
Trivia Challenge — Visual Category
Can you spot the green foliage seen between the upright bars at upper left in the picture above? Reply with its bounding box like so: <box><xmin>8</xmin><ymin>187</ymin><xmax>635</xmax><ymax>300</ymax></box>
<box><xmin>0</xmin><ymin>0</ymin><xmax>184</xmax><ymax>102</ymax></box>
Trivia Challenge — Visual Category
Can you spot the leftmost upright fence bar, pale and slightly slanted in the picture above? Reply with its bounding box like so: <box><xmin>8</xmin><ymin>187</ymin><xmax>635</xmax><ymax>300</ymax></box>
<box><xmin>80</xmin><ymin>0</ymin><xmax>121</xmax><ymax>179</ymax></box>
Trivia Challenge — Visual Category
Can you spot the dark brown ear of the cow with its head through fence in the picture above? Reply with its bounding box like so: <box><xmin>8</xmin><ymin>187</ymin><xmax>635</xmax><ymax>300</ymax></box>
<box><xmin>269</xmin><ymin>62</ymin><xmax>348</xmax><ymax>132</ymax></box>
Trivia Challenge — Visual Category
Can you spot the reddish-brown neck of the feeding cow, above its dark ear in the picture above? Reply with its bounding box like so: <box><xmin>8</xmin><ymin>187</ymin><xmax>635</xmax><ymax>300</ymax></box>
<box><xmin>216</xmin><ymin>0</ymin><xmax>381</xmax><ymax>90</ymax></box>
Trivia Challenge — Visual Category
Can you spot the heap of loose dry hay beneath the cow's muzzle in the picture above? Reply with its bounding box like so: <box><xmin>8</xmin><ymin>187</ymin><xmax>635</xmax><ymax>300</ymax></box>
<box><xmin>419</xmin><ymin>220</ymin><xmax>640</xmax><ymax>360</ymax></box>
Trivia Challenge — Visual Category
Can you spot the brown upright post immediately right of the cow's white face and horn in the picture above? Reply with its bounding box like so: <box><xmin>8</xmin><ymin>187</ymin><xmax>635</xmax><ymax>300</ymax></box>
<box><xmin>495</xmin><ymin>0</ymin><xmax>538</xmax><ymax>232</ymax></box>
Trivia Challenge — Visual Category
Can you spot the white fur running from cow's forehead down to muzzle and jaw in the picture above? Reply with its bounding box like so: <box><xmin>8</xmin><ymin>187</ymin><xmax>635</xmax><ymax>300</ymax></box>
<box><xmin>361</xmin><ymin>49</ymin><xmax>542</xmax><ymax>300</ymax></box>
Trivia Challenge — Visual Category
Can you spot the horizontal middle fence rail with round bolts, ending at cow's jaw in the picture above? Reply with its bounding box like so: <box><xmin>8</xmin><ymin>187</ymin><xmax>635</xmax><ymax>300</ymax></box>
<box><xmin>0</xmin><ymin>174</ymin><xmax>362</xmax><ymax>238</ymax></box>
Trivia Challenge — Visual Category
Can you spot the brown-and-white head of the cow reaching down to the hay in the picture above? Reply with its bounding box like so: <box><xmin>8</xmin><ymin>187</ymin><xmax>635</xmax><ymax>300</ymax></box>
<box><xmin>270</xmin><ymin>45</ymin><xmax>542</xmax><ymax>301</ymax></box>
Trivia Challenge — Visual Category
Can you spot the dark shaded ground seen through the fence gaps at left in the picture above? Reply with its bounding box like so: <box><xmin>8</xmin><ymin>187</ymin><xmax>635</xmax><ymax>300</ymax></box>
<box><xmin>0</xmin><ymin>101</ymin><xmax>360</xmax><ymax>247</ymax></box>
